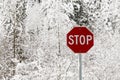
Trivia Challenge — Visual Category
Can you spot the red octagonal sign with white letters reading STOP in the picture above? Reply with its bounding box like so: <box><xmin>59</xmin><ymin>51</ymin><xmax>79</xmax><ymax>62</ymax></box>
<box><xmin>67</xmin><ymin>26</ymin><xmax>94</xmax><ymax>53</ymax></box>
